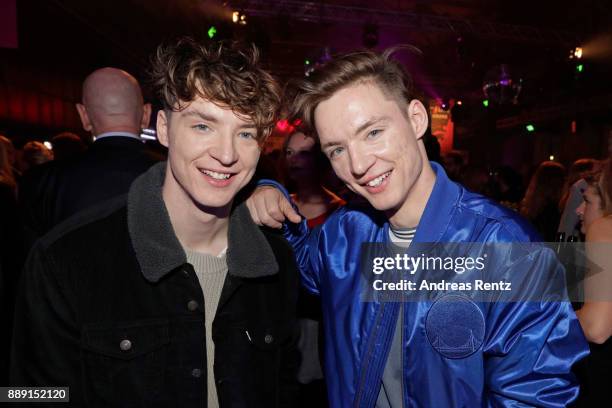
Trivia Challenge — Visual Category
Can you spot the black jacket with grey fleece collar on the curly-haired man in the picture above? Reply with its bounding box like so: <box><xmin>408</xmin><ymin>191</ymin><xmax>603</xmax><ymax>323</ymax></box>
<box><xmin>11</xmin><ymin>163</ymin><xmax>298</xmax><ymax>408</ymax></box>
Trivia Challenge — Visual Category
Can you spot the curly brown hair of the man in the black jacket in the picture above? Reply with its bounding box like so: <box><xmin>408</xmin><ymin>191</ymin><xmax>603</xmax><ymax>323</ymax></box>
<box><xmin>150</xmin><ymin>37</ymin><xmax>281</xmax><ymax>142</ymax></box>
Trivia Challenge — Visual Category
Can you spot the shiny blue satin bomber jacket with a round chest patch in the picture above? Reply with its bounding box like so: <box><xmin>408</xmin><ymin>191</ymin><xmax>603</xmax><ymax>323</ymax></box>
<box><xmin>260</xmin><ymin>162</ymin><xmax>588</xmax><ymax>408</ymax></box>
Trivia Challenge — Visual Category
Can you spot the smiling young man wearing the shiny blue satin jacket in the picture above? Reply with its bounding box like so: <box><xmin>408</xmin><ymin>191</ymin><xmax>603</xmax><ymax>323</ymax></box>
<box><xmin>249</xmin><ymin>51</ymin><xmax>588</xmax><ymax>408</ymax></box>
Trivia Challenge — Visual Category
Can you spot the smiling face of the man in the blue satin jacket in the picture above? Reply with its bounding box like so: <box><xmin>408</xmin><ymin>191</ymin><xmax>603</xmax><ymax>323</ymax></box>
<box><xmin>314</xmin><ymin>81</ymin><xmax>427</xmax><ymax>218</ymax></box>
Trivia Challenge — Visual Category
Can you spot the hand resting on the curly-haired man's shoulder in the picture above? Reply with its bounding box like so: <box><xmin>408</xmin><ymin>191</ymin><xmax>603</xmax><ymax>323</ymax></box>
<box><xmin>246</xmin><ymin>186</ymin><xmax>302</xmax><ymax>228</ymax></box>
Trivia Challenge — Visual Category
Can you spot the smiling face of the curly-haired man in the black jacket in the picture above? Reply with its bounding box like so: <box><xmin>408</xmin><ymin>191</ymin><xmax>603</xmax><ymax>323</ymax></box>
<box><xmin>157</xmin><ymin>97</ymin><xmax>260</xmax><ymax>209</ymax></box>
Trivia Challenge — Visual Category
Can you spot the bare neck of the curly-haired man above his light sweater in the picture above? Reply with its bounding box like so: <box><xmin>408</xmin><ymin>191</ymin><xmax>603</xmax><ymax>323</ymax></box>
<box><xmin>162</xmin><ymin>168</ymin><xmax>232</xmax><ymax>255</ymax></box>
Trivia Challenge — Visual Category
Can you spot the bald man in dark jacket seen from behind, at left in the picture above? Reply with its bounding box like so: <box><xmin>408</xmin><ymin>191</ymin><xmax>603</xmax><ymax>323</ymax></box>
<box><xmin>20</xmin><ymin>68</ymin><xmax>161</xmax><ymax>239</ymax></box>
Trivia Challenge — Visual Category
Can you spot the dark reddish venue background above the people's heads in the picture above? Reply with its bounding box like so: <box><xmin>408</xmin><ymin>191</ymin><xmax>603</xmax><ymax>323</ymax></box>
<box><xmin>0</xmin><ymin>0</ymin><xmax>612</xmax><ymax>173</ymax></box>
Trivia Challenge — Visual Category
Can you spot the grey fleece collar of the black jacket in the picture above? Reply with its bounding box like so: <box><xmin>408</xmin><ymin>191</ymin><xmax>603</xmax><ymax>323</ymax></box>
<box><xmin>127</xmin><ymin>162</ymin><xmax>278</xmax><ymax>282</ymax></box>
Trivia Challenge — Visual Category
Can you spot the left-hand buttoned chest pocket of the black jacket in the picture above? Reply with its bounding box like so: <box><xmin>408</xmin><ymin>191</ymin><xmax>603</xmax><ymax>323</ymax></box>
<box><xmin>81</xmin><ymin>319</ymin><xmax>170</xmax><ymax>406</ymax></box>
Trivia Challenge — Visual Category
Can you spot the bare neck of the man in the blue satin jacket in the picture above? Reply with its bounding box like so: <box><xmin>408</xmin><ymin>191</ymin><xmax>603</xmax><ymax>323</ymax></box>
<box><xmin>387</xmin><ymin>161</ymin><xmax>436</xmax><ymax>228</ymax></box>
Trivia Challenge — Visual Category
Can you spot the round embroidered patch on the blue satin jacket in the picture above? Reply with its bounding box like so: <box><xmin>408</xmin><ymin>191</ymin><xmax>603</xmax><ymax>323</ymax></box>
<box><xmin>425</xmin><ymin>295</ymin><xmax>485</xmax><ymax>358</ymax></box>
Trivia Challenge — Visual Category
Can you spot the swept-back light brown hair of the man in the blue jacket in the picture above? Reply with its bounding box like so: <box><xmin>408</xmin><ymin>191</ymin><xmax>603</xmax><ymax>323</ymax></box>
<box><xmin>287</xmin><ymin>45</ymin><xmax>421</xmax><ymax>136</ymax></box>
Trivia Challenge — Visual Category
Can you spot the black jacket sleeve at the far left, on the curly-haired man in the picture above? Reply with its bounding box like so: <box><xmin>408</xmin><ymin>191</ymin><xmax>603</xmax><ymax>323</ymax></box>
<box><xmin>10</xmin><ymin>241</ymin><xmax>84</xmax><ymax>403</ymax></box>
